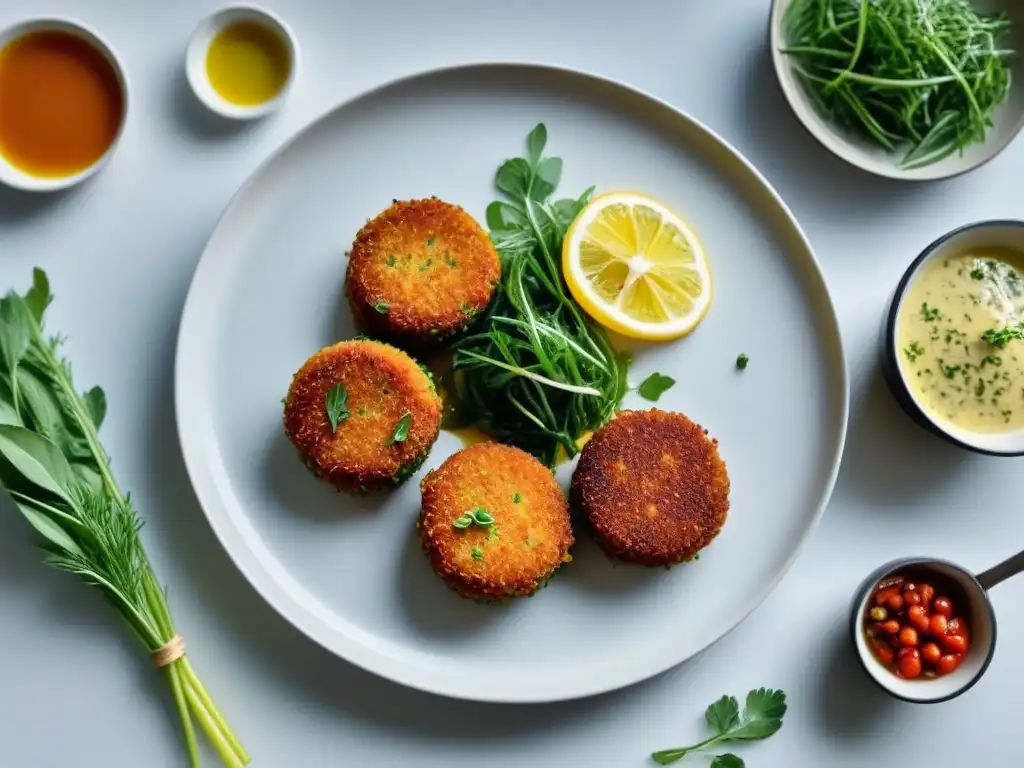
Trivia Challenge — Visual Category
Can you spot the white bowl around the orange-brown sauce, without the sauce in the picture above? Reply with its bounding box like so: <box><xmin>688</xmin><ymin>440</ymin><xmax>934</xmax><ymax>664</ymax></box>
<box><xmin>0</xmin><ymin>17</ymin><xmax>128</xmax><ymax>193</ymax></box>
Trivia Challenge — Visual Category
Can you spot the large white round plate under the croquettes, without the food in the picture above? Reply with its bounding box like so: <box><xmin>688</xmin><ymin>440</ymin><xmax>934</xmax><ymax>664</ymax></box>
<box><xmin>175</xmin><ymin>65</ymin><xmax>848</xmax><ymax>701</ymax></box>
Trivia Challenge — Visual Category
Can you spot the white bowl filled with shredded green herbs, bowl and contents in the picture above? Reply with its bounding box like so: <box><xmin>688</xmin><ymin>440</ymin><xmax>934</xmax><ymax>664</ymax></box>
<box><xmin>770</xmin><ymin>0</ymin><xmax>1024</xmax><ymax>181</ymax></box>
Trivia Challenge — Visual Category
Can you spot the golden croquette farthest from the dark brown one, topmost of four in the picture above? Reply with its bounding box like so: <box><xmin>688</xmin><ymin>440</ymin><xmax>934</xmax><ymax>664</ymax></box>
<box><xmin>346</xmin><ymin>198</ymin><xmax>502</xmax><ymax>346</ymax></box>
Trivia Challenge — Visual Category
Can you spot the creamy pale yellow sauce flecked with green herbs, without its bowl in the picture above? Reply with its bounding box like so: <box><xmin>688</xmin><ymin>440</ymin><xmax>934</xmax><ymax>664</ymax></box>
<box><xmin>896</xmin><ymin>251</ymin><xmax>1024</xmax><ymax>433</ymax></box>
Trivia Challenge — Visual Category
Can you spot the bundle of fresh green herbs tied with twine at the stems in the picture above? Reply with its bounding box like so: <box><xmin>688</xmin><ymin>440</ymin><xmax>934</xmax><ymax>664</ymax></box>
<box><xmin>0</xmin><ymin>269</ymin><xmax>250</xmax><ymax>768</ymax></box>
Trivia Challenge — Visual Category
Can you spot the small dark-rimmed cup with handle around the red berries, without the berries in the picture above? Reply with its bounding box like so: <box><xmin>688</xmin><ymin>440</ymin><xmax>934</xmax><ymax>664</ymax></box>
<box><xmin>850</xmin><ymin>552</ymin><xmax>1024</xmax><ymax>703</ymax></box>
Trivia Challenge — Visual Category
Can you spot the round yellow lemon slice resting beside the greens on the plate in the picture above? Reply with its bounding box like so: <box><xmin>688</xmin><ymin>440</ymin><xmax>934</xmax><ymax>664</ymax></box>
<box><xmin>562</xmin><ymin>193</ymin><xmax>712</xmax><ymax>341</ymax></box>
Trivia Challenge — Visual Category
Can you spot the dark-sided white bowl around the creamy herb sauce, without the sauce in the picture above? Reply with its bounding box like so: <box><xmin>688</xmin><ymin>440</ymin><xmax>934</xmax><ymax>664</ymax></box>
<box><xmin>882</xmin><ymin>219</ymin><xmax>1024</xmax><ymax>456</ymax></box>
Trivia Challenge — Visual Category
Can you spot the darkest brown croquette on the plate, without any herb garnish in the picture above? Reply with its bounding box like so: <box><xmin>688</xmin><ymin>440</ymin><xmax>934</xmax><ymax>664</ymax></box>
<box><xmin>571</xmin><ymin>409</ymin><xmax>729</xmax><ymax>566</ymax></box>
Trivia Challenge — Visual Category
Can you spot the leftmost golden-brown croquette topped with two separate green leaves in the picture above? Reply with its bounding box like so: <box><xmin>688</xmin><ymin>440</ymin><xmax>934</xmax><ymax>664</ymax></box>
<box><xmin>285</xmin><ymin>339</ymin><xmax>441</xmax><ymax>492</ymax></box>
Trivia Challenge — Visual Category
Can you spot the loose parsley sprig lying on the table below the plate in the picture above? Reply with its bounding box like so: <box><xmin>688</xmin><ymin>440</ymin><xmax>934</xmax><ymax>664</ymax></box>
<box><xmin>651</xmin><ymin>688</ymin><xmax>785</xmax><ymax>768</ymax></box>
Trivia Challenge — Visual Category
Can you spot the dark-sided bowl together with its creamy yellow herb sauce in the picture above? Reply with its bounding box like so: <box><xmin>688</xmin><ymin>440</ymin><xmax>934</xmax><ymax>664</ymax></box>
<box><xmin>882</xmin><ymin>221</ymin><xmax>1024</xmax><ymax>456</ymax></box>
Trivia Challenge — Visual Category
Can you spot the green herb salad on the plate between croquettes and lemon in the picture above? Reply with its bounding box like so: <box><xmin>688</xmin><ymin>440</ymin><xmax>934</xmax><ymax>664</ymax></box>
<box><xmin>453</xmin><ymin>124</ymin><xmax>628</xmax><ymax>466</ymax></box>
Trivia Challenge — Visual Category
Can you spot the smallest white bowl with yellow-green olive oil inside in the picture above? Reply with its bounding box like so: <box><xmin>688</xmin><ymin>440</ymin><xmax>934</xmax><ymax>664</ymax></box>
<box><xmin>185</xmin><ymin>6</ymin><xmax>299</xmax><ymax>120</ymax></box>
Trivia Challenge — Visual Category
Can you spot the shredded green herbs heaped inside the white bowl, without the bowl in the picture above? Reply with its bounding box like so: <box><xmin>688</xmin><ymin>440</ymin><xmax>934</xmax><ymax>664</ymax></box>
<box><xmin>783</xmin><ymin>0</ymin><xmax>1014</xmax><ymax>170</ymax></box>
